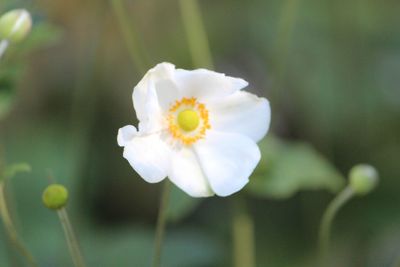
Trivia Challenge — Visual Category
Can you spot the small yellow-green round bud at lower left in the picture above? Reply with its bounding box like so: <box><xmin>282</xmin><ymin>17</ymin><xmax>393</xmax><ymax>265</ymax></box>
<box><xmin>42</xmin><ymin>184</ymin><xmax>68</xmax><ymax>210</ymax></box>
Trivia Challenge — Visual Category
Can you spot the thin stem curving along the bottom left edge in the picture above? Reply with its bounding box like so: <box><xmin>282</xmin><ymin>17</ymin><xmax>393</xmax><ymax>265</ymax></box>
<box><xmin>0</xmin><ymin>181</ymin><xmax>37</xmax><ymax>267</ymax></box>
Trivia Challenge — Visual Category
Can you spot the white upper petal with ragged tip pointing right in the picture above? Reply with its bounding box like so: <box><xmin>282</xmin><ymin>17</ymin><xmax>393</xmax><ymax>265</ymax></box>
<box><xmin>175</xmin><ymin>69</ymin><xmax>248</xmax><ymax>102</ymax></box>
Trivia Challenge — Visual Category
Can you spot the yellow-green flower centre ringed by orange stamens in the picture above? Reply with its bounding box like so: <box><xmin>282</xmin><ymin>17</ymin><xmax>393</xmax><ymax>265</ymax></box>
<box><xmin>167</xmin><ymin>97</ymin><xmax>211</xmax><ymax>145</ymax></box>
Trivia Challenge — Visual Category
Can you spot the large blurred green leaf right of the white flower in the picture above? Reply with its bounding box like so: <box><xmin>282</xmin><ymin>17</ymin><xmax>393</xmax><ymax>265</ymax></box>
<box><xmin>248</xmin><ymin>136</ymin><xmax>344</xmax><ymax>198</ymax></box>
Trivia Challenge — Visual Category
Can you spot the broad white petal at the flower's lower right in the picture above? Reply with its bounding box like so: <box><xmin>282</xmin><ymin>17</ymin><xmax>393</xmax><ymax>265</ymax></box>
<box><xmin>194</xmin><ymin>130</ymin><xmax>261</xmax><ymax>196</ymax></box>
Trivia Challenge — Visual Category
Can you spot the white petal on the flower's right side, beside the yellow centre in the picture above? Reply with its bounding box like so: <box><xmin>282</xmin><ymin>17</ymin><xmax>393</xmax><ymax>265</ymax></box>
<box><xmin>207</xmin><ymin>91</ymin><xmax>271</xmax><ymax>142</ymax></box>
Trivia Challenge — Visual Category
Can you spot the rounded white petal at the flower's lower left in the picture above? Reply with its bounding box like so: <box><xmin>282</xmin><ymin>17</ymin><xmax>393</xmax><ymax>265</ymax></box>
<box><xmin>124</xmin><ymin>134</ymin><xmax>171</xmax><ymax>183</ymax></box>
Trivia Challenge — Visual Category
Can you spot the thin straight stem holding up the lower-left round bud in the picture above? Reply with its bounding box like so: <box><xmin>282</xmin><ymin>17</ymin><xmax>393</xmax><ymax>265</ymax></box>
<box><xmin>57</xmin><ymin>208</ymin><xmax>85</xmax><ymax>267</ymax></box>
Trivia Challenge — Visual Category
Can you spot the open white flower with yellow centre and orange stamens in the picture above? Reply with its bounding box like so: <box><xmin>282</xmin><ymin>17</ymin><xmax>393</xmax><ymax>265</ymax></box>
<box><xmin>118</xmin><ymin>63</ymin><xmax>271</xmax><ymax>197</ymax></box>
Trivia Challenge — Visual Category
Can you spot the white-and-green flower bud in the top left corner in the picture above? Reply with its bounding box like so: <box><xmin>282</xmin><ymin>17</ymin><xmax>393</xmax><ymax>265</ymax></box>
<box><xmin>0</xmin><ymin>9</ymin><xmax>32</xmax><ymax>43</ymax></box>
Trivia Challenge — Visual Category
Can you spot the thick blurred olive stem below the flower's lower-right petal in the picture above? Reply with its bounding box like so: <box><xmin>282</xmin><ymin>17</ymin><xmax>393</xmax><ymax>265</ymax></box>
<box><xmin>232</xmin><ymin>197</ymin><xmax>256</xmax><ymax>267</ymax></box>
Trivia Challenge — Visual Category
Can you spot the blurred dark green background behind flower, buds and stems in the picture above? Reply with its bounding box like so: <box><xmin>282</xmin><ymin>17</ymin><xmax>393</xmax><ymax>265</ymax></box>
<box><xmin>0</xmin><ymin>0</ymin><xmax>400</xmax><ymax>267</ymax></box>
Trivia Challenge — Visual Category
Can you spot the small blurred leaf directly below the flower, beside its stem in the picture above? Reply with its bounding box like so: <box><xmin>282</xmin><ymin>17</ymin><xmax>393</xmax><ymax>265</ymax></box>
<box><xmin>168</xmin><ymin>186</ymin><xmax>201</xmax><ymax>221</ymax></box>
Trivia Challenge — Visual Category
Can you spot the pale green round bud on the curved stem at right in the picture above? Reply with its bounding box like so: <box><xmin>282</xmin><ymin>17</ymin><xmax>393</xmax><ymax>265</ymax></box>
<box><xmin>349</xmin><ymin>164</ymin><xmax>379</xmax><ymax>195</ymax></box>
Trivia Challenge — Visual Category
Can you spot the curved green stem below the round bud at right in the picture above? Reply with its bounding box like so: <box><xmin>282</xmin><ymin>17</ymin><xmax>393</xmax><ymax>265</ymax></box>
<box><xmin>319</xmin><ymin>186</ymin><xmax>354</xmax><ymax>262</ymax></box>
